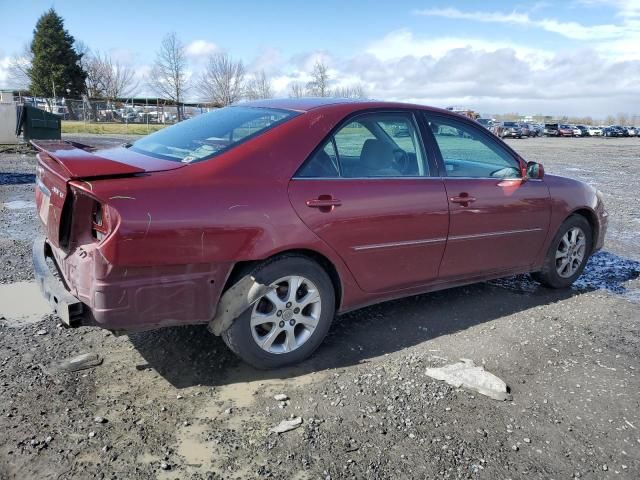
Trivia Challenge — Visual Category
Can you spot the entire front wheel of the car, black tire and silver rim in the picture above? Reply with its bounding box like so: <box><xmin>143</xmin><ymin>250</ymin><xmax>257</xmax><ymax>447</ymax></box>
<box><xmin>531</xmin><ymin>215</ymin><xmax>593</xmax><ymax>288</ymax></box>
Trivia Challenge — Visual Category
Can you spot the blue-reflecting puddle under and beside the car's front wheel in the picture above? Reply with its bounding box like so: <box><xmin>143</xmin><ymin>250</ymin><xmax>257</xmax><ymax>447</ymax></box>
<box><xmin>489</xmin><ymin>251</ymin><xmax>640</xmax><ymax>302</ymax></box>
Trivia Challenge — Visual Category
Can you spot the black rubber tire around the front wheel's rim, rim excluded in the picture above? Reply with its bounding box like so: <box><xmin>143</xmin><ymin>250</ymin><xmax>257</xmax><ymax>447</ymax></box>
<box><xmin>531</xmin><ymin>215</ymin><xmax>593</xmax><ymax>288</ymax></box>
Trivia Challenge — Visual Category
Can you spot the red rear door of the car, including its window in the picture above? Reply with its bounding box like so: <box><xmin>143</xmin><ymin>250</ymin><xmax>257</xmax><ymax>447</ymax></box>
<box><xmin>289</xmin><ymin>111</ymin><xmax>449</xmax><ymax>292</ymax></box>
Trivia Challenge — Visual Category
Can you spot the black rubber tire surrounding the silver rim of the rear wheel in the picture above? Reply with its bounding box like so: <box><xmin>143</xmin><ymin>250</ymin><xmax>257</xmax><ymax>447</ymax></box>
<box><xmin>222</xmin><ymin>254</ymin><xmax>336</xmax><ymax>370</ymax></box>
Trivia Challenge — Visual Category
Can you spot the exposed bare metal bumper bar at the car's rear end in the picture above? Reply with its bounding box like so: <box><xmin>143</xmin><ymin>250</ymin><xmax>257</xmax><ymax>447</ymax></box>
<box><xmin>33</xmin><ymin>236</ymin><xmax>86</xmax><ymax>327</ymax></box>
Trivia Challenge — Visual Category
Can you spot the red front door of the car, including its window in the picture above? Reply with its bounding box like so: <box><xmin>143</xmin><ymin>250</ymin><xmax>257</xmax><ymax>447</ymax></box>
<box><xmin>425</xmin><ymin>114</ymin><xmax>551</xmax><ymax>280</ymax></box>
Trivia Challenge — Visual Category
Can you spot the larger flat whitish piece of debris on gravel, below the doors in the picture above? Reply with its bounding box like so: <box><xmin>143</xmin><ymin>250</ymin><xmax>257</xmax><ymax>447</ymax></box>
<box><xmin>426</xmin><ymin>358</ymin><xmax>512</xmax><ymax>400</ymax></box>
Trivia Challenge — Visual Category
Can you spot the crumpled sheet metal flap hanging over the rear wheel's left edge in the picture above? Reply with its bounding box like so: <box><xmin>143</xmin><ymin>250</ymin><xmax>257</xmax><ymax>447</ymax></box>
<box><xmin>208</xmin><ymin>275</ymin><xmax>275</xmax><ymax>335</ymax></box>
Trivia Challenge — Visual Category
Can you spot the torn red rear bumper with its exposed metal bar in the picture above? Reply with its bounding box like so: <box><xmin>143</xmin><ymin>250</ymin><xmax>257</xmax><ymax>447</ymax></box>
<box><xmin>33</xmin><ymin>237</ymin><xmax>232</xmax><ymax>332</ymax></box>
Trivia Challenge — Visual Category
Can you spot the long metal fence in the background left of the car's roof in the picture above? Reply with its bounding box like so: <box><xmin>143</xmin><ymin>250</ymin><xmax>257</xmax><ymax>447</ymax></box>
<box><xmin>15</xmin><ymin>97</ymin><xmax>213</xmax><ymax>125</ymax></box>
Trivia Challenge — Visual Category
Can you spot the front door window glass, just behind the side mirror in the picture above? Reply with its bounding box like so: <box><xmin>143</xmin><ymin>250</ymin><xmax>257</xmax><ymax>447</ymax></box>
<box><xmin>427</xmin><ymin>117</ymin><xmax>522</xmax><ymax>178</ymax></box>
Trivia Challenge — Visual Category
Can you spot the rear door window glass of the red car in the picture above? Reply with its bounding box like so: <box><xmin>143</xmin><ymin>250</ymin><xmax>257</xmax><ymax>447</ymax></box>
<box><xmin>296</xmin><ymin>112</ymin><xmax>429</xmax><ymax>178</ymax></box>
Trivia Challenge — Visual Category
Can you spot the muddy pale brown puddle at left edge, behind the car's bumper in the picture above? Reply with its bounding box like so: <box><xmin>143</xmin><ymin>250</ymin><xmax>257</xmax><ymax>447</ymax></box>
<box><xmin>0</xmin><ymin>282</ymin><xmax>51</xmax><ymax>327</ymax></box>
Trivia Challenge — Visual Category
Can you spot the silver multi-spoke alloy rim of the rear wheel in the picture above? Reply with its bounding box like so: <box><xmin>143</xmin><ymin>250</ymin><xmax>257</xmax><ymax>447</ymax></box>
<box><xmin>251</xmin><ymin>276</ymin><xmax>322</xmax><ymax>354</ymax></box>
